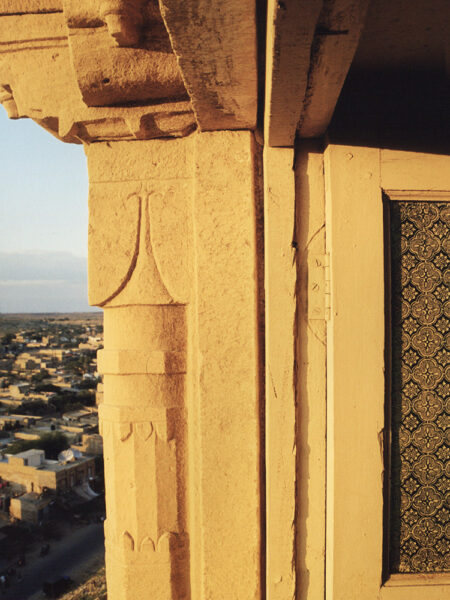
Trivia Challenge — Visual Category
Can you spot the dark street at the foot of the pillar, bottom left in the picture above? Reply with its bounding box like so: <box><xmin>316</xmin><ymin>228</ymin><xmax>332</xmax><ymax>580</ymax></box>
<box><xmin>0</xmin><ymin>523</ymin><xmax>105</xmax><ymax>600</ymax></box>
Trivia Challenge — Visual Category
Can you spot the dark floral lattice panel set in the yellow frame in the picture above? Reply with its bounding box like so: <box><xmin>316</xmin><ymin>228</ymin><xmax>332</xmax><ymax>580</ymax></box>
<box><xmin>390</xmin><ymin>202</ymin><xmax>450</xmax><ymax>573</ymax></box>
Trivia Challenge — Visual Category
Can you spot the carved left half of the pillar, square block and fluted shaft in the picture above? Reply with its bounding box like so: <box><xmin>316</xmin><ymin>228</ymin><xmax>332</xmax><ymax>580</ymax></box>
<box><xmin>89</xmin><ymin>137</ymin><xmax>192</xmax><ymax>600</ymax></box>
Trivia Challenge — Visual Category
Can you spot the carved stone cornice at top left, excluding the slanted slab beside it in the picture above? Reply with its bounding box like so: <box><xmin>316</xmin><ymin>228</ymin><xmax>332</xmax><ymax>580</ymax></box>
<box><xmin>0</xmin><ymin>0</ymin><xmax>196</xmax><ymax>143</ymax></box>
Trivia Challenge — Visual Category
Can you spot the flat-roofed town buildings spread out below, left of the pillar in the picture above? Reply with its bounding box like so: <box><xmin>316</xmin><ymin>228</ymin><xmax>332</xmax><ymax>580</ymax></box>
<box><xmin>0</xmin><ymin>318</ymin><xmax>103</xmax><ymax>524</ymax></box>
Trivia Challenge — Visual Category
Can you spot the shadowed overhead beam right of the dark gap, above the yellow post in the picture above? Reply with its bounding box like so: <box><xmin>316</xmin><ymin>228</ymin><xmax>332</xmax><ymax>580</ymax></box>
<box><xmin>265</xmin><ymin>0</ymin><xmax>368</xmax><ymax>146</ymax></box>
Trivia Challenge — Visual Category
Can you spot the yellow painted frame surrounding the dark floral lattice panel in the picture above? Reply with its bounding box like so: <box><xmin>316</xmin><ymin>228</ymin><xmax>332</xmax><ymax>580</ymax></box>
<box><xmin>324</xmin><ymin>145</ymin><xmax>450</xmax><ymax>600</ymax></box>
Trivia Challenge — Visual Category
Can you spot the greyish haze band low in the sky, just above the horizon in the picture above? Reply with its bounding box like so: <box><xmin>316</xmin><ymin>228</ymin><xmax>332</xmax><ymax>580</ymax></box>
<box><xmin>0</xmin><ymin>251</ymin><xmax>94</xmax><ymax>313</ymax></box>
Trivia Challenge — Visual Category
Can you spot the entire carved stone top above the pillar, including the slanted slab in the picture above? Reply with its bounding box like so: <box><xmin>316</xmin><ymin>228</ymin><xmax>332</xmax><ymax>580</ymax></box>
<box><xmin>0</xmin><ymin>0</ymin><xmax>257</xmax><ymax>143</ymax></box>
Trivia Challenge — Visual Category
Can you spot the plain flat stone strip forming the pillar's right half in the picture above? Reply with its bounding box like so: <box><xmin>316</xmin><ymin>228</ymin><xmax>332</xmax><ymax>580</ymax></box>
<box><xmin>189</xmin><ymin>132</ymin><xmax>261</xmax><ymax>600</ymax></box>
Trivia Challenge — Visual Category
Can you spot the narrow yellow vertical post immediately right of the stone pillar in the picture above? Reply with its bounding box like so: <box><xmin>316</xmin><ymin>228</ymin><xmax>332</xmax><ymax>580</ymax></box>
<box><xmin>264</xmin><ymin>147</ymin><xmax>298</xmax><ymax>600</ymax></box>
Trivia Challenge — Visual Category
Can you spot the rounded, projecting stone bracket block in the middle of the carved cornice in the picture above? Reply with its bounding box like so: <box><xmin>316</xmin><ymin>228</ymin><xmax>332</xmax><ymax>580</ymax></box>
<box><xmin>64</xmin><ymin>0</ymin><xmax>188</xmax><ymax>106</ymax></box>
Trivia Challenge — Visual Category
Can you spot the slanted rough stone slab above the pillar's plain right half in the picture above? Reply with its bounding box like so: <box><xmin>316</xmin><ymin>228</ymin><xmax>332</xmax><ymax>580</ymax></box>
<box><xmin>160</xmin><ymin>0</ymin><xmax>258</xmax><ymax>131</ymax></box>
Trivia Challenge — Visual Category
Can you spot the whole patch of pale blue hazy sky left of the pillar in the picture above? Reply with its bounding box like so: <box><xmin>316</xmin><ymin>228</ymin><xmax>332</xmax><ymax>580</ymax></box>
<box><xmin>0</xmin><ymin>107</ymin><xmax>95</xmax><ymax>312</ymax></box>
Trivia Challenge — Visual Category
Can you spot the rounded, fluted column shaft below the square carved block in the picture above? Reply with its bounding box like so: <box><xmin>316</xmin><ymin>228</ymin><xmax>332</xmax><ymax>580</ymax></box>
<box><xmin>99</xmin><ymin>350</ymin><xmax>190</xmax><ymax>600</ymax></box>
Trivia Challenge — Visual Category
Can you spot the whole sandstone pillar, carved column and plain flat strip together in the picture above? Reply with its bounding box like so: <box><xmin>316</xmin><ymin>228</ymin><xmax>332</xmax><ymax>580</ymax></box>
<box><xmin>87</xmin><ymin>132</ymin><xmax>260</xmax><ymax>600</ymax></box>
